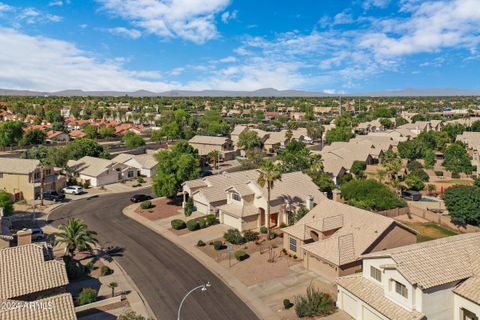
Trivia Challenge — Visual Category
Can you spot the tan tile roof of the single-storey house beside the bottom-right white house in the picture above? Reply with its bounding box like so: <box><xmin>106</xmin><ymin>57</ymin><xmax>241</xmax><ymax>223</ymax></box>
<box><xmin>283</xmin><ymin>199</ymin><xmax>398</xmax><ymax>265</ymax></box>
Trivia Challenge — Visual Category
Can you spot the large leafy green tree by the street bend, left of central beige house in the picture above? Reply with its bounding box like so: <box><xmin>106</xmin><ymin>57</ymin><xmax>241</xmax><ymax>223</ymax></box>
<box><xmin>153</xmin><ymin>141</ymin><xmax>200</xmax><ymax>197</ymax></box>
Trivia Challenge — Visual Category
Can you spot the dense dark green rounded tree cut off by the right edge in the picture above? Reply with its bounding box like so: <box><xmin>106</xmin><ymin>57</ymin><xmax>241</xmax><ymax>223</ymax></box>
<box><xmin>443</xmin><ymin>185</ymin><xmax>480</xmax><ymax>226</ymax></box>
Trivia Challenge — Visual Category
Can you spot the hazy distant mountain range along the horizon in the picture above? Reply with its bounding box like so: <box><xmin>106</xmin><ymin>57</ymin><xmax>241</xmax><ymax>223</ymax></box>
<box><xmin>0</xmin><ymin>88</ymin><xmax>480</xmax><ymax>97</ymax></box>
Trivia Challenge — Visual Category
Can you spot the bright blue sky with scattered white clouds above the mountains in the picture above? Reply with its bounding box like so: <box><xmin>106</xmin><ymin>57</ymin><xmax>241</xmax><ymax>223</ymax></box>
<box><xmin>0</xmin><ymin>0</ymin><xmax>480</xmax><ymax>93</ymax></box>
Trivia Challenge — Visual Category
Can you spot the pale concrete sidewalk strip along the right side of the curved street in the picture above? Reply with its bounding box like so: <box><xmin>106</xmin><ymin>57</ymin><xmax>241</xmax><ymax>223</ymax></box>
<box><xmin>122</xmin><ymin>204</ymin><xmax>278</xmax><ymax>320</ymax></box>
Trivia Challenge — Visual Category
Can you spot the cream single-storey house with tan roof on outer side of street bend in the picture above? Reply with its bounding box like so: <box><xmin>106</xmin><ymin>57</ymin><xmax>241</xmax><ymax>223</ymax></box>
<box><xmin>67</xmin><ymin>156</ymin><xmax>138</xmax><ymax>187</ymax></box>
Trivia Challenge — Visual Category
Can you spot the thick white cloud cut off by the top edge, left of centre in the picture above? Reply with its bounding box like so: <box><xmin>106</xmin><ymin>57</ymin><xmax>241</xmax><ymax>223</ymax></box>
<box><xmin>97</xmin><ymin>0</ymin><xmax>230</xmax><ymax>44</ymax></box>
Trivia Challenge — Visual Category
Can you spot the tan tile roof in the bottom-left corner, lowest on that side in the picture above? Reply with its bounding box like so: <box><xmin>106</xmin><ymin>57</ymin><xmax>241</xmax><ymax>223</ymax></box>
<box><xmin>0</xmin><ymin>293</ymin><xmax>77</xmax><ymax>320</ymax></box>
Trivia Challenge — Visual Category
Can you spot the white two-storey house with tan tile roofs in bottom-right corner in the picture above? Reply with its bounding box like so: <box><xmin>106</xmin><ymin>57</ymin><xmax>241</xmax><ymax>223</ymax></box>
<box><xmin>337</xmin><ymin>233</ymin><xmax>480</xmax><ymax>320</ymax></box>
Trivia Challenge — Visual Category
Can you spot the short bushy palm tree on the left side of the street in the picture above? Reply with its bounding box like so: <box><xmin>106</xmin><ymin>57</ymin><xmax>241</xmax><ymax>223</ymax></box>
<box><xmin>55</xmin><ymin>218</ymin><xmax>98</xmax><ymax>257</ymax></box>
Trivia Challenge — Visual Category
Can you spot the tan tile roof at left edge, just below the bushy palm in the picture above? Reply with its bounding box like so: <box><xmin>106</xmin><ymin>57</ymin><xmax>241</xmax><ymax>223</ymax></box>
<box><xmin>0</xmin><ymin>244</ymin><xmax>68</xmax><ymax>299</ymax></box>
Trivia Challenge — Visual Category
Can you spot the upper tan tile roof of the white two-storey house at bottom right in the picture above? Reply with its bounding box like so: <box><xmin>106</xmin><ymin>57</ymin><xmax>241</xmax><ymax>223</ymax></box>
<box><xmin>363</xmin><ymin>233</ymin><xmax>480</xmax><ymax>289</ymax></box>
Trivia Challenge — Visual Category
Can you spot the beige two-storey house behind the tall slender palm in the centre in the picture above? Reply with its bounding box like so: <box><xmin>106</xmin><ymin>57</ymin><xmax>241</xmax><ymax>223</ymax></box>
<box><xmin>183</xmin><ymin>170</ymin><xmax>326</xmax><ymax>231</ymax></box>
